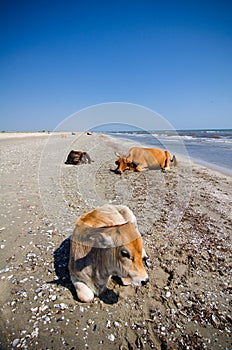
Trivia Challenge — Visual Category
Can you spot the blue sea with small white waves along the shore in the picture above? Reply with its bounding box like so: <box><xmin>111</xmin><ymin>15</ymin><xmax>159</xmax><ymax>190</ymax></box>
<box><xmin>109</xmin><ymin>129</ymin><xmax>232</xmax><ymax>176</ymax></box>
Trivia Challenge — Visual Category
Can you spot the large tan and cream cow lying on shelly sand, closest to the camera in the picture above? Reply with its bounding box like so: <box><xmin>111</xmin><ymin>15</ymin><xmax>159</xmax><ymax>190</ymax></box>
<box><xmin>69</xmin><ymin>204</ymin><xmax>148</xmax><ymax>302</ymax></box>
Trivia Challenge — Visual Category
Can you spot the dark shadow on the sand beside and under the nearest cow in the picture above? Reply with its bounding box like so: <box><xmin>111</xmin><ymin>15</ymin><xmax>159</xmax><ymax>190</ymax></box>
<box><xmin>49</xmin><ymin>238</ymin><xmax>118</xmax><ymax>304</ymax></box>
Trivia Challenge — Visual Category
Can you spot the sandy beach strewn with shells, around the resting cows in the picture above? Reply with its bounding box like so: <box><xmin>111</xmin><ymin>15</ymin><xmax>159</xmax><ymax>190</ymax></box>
<box><xmin>0</xmin><ymin>133</ymin><xmax>232</xmax><ymax>350</ymax></box>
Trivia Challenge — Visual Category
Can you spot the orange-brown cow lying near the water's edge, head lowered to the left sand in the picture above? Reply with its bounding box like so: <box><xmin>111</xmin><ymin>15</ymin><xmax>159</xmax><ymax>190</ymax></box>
<box><xmin>115</xmin><ymin>147</ymin><xmax>177</xmax><ymax>174</ymax></box>
